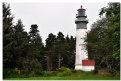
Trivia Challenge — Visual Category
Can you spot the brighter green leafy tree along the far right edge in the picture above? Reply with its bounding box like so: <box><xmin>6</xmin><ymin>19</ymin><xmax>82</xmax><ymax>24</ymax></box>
<box><xmin>101</xmin><ymin>3</ymin><xmax>120</xmax><ymax>71</ymax></box>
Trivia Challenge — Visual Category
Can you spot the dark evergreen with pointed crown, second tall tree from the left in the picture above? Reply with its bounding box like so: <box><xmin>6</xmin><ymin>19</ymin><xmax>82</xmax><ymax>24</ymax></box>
<box><xmin>13</xmin><ymin>20</ymin><xmax>29</xmax><ymax>68</ymax></box>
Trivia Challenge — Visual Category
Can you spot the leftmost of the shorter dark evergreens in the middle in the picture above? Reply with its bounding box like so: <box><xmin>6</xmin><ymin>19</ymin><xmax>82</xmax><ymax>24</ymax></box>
<box><xmin>45</xmin><ymin>33</ymin><xmax>57</xmax><ymax>71</ymax></box>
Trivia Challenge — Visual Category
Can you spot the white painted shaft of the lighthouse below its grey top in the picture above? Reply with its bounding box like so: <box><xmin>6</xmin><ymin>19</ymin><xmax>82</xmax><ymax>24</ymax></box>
<box><xmin>75</xmin><ymin>29</ymin><xmax>88</xmax><ymax>70</ymax></box>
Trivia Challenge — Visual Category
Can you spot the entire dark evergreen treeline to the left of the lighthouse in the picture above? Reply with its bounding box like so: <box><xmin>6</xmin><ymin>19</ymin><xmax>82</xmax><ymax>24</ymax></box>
<box><xmin>2</xmin><ymin>3</ymin><xmax>75</xmax><ymax>76</ymax></box>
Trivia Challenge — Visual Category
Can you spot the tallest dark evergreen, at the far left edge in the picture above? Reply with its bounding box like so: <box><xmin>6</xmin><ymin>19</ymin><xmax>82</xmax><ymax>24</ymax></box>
<box><xmin>3</xmin><ymin>3</ymin><xmax>14</xmax><ymax>68</ymax></box>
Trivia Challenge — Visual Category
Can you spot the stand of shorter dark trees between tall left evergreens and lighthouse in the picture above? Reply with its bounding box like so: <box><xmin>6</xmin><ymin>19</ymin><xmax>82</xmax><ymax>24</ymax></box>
<box><xmin>45</xmin><ymin>32</ymin><xmax>75</xmax><ymax>71</ymax></box>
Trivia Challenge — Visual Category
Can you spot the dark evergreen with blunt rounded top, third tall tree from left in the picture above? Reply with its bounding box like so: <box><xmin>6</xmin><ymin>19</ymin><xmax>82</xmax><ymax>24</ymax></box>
<box><xmin>27</xmin><ymin>24</ymin><xmax>44</xmax><ymax>73</ymax></box>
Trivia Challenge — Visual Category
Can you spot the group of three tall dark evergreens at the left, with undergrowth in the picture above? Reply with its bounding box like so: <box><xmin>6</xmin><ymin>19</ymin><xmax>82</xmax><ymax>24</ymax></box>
<box><xmin>3</xmin><ymin>3</ymin><xmax>44</xmax><ymax>77</ymax></box>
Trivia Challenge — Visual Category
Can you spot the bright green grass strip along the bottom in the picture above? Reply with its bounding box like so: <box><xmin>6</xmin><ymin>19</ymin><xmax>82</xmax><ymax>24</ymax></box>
<box><xmin>5</xmin><ymin>71</ymin><xmax>120</xmax><ymax>80</ymax></box>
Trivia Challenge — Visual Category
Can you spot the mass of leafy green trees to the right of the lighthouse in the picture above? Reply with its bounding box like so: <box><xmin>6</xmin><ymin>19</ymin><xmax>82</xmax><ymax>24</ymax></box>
<box><xmin>86</xmin><ymin>3</ymin><xmax>120</xmax><ymax>73</ymax></box>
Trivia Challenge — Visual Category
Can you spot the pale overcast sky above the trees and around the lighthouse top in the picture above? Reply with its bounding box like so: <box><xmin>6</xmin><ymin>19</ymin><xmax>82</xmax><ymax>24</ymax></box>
<box><xmin>10</xmin><ymin>2</ymin><xmax>107</xmax><ymax>42</ymax></box>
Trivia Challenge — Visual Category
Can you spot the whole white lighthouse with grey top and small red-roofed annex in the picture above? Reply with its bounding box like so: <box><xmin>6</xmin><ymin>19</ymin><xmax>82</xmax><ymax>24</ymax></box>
<box><xmin>75</xmin><ymin>5</ymin><xmax>95</xmax><ymax>71</ymax></box>
